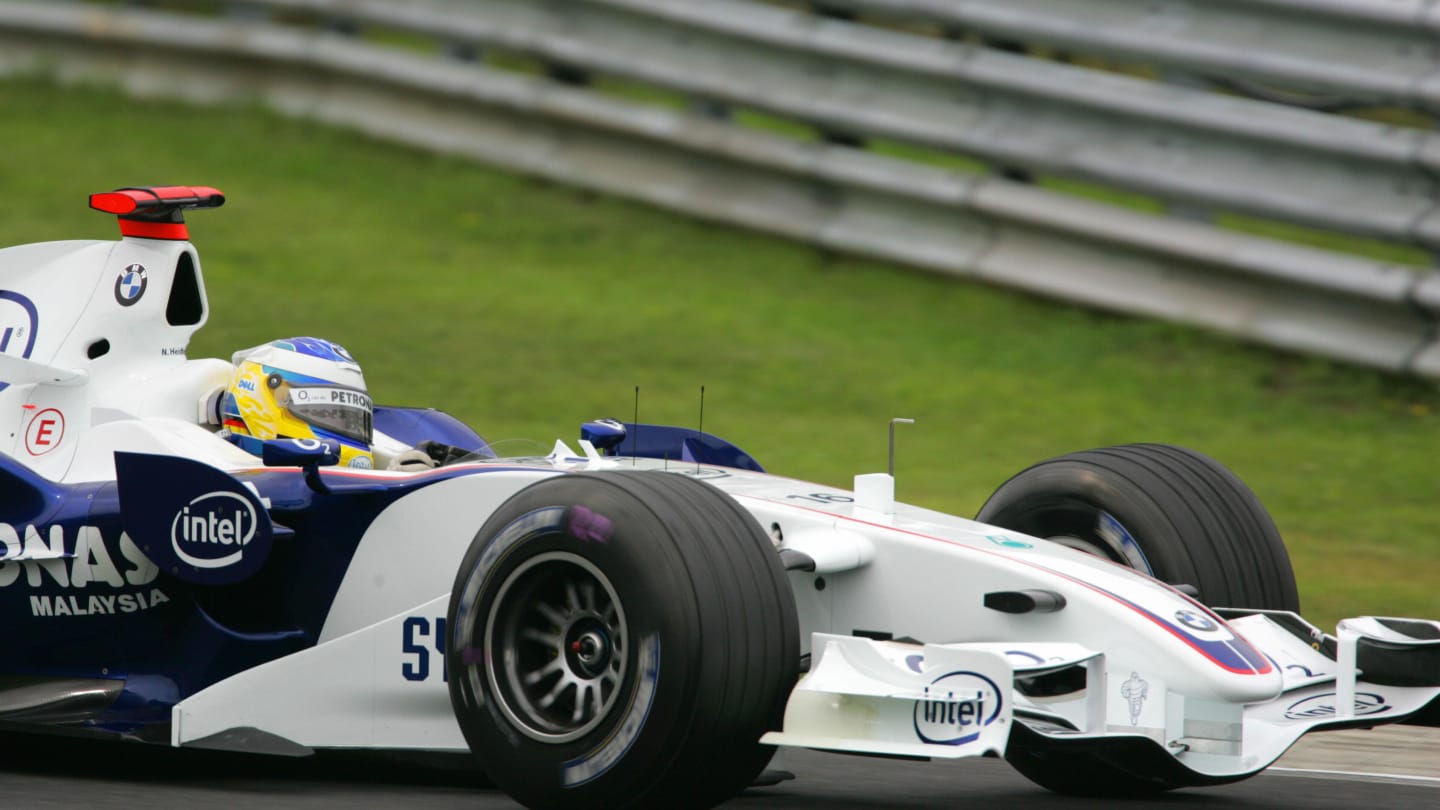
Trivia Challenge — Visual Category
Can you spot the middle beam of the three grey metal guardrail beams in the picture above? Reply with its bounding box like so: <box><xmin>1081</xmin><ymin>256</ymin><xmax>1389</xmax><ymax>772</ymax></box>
<box><xmin>227</xmin><ymin>0</ymin><xmax>1440</xmax><ymax>248</ymax></box>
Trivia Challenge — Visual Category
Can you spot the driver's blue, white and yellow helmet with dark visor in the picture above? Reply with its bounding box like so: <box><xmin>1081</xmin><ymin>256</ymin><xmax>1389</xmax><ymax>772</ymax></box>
<box><xmin>220</xmin><ymin>337</ymin><xmax>374</xmax><ymax>468</ymax></box>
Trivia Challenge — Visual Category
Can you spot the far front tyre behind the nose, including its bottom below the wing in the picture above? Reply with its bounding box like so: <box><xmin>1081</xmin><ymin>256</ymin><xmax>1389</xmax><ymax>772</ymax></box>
<box><xmin>976</xmin><ymin>444</ymin><xmax>1299</xmax><ymax>798</ymax></box>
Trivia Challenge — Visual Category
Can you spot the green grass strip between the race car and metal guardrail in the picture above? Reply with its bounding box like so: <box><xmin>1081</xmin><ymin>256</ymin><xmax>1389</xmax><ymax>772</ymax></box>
<box><xmin>0</xmin><ymin>81</ymin><xmax>1440</xmax><ymax>623</ymax></box>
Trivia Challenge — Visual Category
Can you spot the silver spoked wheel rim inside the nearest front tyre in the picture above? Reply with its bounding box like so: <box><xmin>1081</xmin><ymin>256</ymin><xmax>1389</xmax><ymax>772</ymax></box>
<box><xmin>485</xmin><ymin>552</ymin><xmax>629</xmax><ymax>744</ymax></box>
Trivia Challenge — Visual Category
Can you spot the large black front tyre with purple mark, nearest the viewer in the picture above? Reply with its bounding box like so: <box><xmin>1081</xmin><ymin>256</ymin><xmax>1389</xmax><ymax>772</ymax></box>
<box><xmin>446</xmin><ymin>470</ymin><xmax>799</xmax><ymax>809</ymax></box>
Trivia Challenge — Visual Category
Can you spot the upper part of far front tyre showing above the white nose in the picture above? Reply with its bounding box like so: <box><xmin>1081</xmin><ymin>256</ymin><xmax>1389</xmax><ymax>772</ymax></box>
<box><xmin>976</xmin><ymin>444</ymin><xmax>1300</xmax><ymax>611</ymax></box>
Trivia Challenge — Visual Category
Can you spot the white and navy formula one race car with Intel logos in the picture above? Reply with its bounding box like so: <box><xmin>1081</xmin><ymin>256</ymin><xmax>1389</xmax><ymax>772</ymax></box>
<box><xmin>0</xmin><ymin>186</ymin><xmax>1440</xmax><ymax>809</ymax></box>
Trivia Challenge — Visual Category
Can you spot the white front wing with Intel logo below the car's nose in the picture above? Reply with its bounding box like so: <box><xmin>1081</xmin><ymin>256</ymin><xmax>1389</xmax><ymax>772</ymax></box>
<box><xmin>762</xmin><ymin>613</ymin><xmax>1440</xmax><ymax>785</ymax></box>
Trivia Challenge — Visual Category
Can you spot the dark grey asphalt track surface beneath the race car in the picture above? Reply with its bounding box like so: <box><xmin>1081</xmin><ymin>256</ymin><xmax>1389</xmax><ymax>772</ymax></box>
<box><xmin>0</xmin><ymin>734</ymin><xmax>1440</xmax><ymax>810</ymax></box>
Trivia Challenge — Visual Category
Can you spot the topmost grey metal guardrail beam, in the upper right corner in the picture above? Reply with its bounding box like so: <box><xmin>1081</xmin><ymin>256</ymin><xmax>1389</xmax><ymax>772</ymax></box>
<box><xmin>824</xmin><ymin>0</ymin><xmax>1440</xmax><ymax>111</ymax></box>
